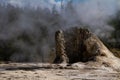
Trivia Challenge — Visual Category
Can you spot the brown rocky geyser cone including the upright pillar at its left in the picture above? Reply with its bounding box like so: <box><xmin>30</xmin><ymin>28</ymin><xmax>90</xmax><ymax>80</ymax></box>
<box><xmin>54</xmin><ymin>28</ymin><xmax>120</xmax><ymax>69</ymax></box>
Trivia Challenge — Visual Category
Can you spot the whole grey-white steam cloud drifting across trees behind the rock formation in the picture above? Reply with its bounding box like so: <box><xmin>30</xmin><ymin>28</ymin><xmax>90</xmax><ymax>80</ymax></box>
<box><xmin>0</xmin><ymin>0</ymin><xmax>120</xmax><ymax>61</ymax></box>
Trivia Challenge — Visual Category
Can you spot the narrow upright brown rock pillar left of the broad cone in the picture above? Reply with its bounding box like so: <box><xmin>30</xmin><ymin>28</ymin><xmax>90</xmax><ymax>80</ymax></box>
<box><xmin>54</xmin><ymin>30</ymin><xmax>69</xmax><ymax>63</ymax></box>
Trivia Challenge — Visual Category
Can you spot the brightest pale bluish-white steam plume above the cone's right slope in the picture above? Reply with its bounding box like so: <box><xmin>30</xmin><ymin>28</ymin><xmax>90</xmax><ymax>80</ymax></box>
<box><xmin>77</xmin><ymin>0</ymin><xmax>117</xmax><ymax>37</ymax></box>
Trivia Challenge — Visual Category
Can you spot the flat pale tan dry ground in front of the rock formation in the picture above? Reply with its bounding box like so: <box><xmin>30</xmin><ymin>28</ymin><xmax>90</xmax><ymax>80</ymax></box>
<box><xmin>0</xmin><ymin>62</ymin><xmax>120</xmax><ymax>80</ymax></box>
